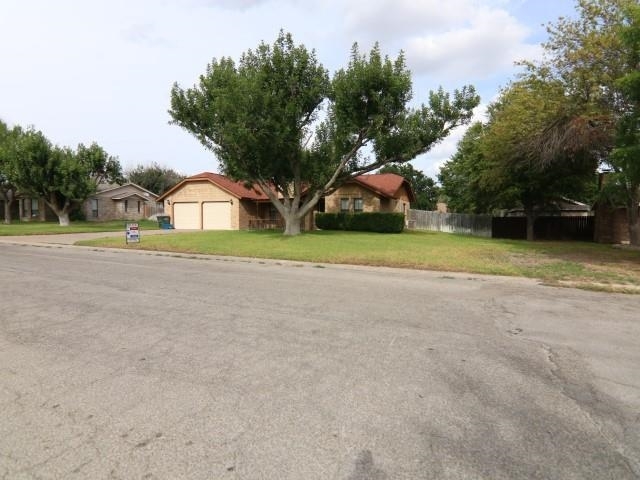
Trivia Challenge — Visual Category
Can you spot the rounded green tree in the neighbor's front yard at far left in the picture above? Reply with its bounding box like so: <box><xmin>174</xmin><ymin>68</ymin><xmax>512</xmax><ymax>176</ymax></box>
<box><xmin>12</xmin><ymin>129</ymin><xmax>122</xmax><ymax>226</ymax></box>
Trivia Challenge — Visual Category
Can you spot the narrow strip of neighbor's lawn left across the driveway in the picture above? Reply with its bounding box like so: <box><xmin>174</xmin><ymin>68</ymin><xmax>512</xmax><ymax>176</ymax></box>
<box><xmin>0</xmin><ymin>220</ymin><xmax>158</xmax><ymax>236</ymax></box>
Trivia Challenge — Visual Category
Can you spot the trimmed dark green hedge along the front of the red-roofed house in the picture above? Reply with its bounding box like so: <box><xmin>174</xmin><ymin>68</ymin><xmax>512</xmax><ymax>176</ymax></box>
<box><xmin>316</xmin><ymin>212</ymin><xmax>404</xmax><ymax>233</ymax></box>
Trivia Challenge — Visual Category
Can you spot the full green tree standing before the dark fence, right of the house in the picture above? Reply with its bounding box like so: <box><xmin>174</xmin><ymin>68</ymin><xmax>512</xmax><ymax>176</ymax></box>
<box><xmin>439</xmin><ymin>76</ymin><xmax>597</xmax><ymax>240</ymax></box>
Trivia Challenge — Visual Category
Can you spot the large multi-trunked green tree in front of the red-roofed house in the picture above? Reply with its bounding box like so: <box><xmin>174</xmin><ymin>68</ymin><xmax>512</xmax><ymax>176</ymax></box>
<box><xmin>169</xmin><ymin>32</ymin><xmax>479</xmax><ymax>235</ymax></box>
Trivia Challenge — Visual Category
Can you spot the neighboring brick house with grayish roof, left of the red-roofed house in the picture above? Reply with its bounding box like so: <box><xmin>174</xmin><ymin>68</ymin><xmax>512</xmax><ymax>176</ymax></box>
<box><xmin>82</xmin><ymin>183</ymin><xmax>163</xmax><ymax>221</ymax></box>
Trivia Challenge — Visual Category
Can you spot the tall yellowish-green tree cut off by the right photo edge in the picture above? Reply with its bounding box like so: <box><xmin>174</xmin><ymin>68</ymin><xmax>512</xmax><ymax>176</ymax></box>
<box><xmin>527</xmin><ymin>0</ymin><xmax>640</xmax><ymax>240</ymax></box>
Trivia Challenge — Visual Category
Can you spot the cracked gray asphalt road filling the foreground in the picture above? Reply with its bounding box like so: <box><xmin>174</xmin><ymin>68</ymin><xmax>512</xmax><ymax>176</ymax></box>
<box><xmin>0</xmin><ymin>243</ymin><xmax>640</xmax><ymax>480</ymax></box>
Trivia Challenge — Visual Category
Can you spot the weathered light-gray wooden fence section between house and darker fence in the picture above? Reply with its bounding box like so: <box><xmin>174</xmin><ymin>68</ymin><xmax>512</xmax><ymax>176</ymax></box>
<box><xmin>408</xmin><ymin>210</ymin><xmax>491</xmax><ymax>237</ymax></box>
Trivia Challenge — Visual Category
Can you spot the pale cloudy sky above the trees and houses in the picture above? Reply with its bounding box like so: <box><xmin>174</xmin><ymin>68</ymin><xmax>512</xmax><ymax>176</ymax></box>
<box><xmin>0</xmin><ymin>0</ymin><xmax>575</xmax><ymax>177</ymax></box>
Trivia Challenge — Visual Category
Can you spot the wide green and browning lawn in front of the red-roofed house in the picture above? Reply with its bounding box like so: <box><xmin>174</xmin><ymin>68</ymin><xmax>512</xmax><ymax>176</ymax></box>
<box><xmin>76</xmin><ymin>231</ymin><xmax>640</xmax><ymax>293</ymax></box>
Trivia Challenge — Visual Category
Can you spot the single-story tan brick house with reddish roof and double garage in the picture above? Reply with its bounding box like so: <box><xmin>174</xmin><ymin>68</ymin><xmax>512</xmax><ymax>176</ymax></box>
<box><xmin>158</xmin><ymin>172</ymin><xmax>415</xmax><ymax>230</ymax></box>
